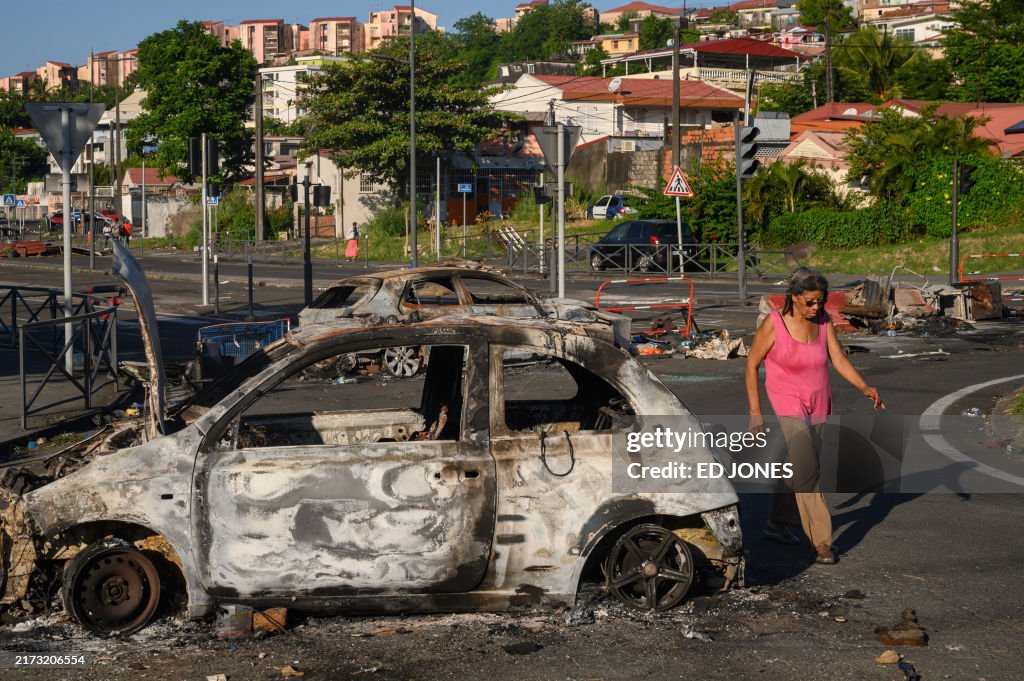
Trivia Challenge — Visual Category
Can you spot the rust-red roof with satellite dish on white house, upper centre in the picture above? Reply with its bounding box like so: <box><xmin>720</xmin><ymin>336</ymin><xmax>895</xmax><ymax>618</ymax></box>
<box><xmin>531</xmin><ymin>76</ymin><xmax>743</xmax><ymax>109</ymax></box>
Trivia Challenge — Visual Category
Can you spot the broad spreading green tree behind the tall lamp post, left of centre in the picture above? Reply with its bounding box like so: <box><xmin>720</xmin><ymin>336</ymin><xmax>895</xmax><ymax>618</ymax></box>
<box><xmin>302</xmin><ymin>36</ymin><xmax>516</xmax><ymax>189</ymax></box>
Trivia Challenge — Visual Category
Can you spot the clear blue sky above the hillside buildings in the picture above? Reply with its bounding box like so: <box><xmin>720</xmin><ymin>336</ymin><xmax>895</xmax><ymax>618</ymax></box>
<box><xmin>0</xmin><ymin>0</ymin><xmax>707</xmax><ymax>77</ymax></box>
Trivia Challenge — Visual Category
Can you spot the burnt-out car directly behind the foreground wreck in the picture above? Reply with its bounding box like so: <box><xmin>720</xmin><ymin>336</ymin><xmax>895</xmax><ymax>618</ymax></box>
<box><xmin>299</xmin><ymin>266</ymin><xmax>629</xmax><ymax>376</ymax></box>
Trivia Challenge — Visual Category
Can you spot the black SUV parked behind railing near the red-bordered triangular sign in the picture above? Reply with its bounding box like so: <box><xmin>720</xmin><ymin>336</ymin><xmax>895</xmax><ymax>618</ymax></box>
<box><xmin>590</xmin><ymin>220</ymin><xmax>699</xmax><ymax>272</ymax></box>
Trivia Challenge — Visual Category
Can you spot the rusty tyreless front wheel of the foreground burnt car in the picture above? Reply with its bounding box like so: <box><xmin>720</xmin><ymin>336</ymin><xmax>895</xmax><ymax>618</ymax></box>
<box><xmin>63</xmin><ymin>540</ymin><xmax>160</xmax><ymax>636</ymax></box>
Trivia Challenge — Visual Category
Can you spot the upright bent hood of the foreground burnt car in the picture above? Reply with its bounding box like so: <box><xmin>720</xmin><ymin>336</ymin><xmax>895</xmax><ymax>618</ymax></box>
<box><xmin>112</xmin><ymin>242</ymin><xmax>167</xmax><ymax>437</ymax></box>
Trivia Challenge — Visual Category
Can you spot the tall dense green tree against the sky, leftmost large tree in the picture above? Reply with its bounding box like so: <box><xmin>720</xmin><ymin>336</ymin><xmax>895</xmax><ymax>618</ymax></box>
<box><xmin>127</xmin><ymin>22</ymin><xmax>256</xmax><ymax>180</ymax></box>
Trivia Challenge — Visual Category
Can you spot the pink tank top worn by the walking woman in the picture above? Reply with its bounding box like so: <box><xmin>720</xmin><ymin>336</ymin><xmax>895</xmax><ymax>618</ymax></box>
<box><xmin>765</xmin><ymin>309</ymin><xmax>831</xmax><ymax>424</ymax></box>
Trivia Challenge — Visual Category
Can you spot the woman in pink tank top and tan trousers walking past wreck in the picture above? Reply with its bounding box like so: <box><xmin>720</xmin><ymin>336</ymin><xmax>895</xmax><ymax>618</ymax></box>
<box><xmin>746</xmin><ymin>267</ymin><xmax>885</xmax><ymax>565</ymax></box>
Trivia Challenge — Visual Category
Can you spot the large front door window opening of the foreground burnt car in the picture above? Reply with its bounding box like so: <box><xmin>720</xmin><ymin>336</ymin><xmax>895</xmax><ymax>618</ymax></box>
<box><xmin>224</xmin><ymin>345</ymin><xmax>466</xmax><ymax>454</ymax></box>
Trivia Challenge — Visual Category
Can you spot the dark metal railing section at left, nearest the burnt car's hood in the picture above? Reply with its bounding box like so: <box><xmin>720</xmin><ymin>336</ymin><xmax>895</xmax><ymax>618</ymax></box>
<box><xmin>15</xmin><ymin>287</ymin><xmax>119</xmax><ymax>430</ymax></box>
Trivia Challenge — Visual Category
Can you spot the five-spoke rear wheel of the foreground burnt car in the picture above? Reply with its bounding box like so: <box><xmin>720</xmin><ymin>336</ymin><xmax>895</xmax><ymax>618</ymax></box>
<box><xmin>604</xmin><ymin>524</ymin><xmax>693</xmax><ymax>610</ymax></box>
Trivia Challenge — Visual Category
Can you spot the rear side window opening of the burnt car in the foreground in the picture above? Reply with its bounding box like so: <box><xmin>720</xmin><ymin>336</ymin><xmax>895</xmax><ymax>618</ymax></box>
<box><xmin>503</xmin><ymin>351</ymin><xmax>635</xmax><ymax>433</ymax></box>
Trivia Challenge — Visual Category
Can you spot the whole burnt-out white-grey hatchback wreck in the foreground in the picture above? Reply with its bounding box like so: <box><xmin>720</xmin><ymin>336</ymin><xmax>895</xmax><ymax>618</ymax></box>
<box><xmin>0</xmin><ymin>248</ymin><xmax>742</xmax><ymax>635</ymax></box>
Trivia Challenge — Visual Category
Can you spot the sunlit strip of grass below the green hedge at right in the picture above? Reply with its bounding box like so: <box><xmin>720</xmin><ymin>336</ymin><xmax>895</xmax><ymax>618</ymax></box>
<box><xmin>806</xmin><ymin>226</ymin><xmax>1024</xmax><ymax>276</ymax></box>
